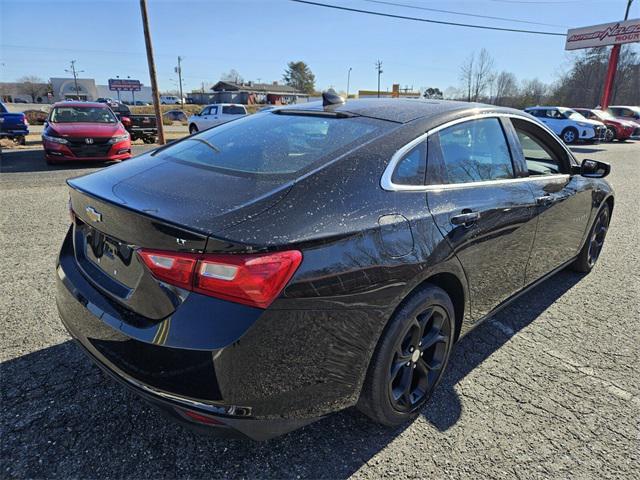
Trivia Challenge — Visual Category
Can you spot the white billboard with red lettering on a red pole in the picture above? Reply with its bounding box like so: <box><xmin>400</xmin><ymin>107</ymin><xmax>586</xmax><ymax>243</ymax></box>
<box><xmin>564</xmin><ymin>19</ymin><xmax>640</xmax><ymax>50</ymax></box>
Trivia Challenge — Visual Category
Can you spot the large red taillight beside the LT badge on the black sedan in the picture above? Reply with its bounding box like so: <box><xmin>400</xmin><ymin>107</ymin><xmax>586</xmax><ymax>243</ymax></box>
<box><xmin>138</xmin><ymin>249</ymin><xmax>302</xmax><ymax>308</ymax></box>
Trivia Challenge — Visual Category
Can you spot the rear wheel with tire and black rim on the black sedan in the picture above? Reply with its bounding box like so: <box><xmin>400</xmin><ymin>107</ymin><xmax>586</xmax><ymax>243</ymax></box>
<box><xmin>357</xmin><ymin>284</ymin><xmax>455</xmax><ymax>426</ymax></box>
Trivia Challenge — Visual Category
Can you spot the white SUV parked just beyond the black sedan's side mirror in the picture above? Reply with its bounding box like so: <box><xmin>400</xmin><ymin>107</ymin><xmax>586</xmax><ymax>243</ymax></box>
<box><xmin>524</xmin><ymin>107</ymin><xmax>607</xmax><ymax>143</ymax></box>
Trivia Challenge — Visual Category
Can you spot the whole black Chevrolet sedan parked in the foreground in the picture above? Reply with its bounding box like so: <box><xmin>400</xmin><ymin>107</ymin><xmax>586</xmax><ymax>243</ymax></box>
<box><xmin>57</xmin><ymin>99</ymin><xmax>614</xmax><ymax>439</ymax></box>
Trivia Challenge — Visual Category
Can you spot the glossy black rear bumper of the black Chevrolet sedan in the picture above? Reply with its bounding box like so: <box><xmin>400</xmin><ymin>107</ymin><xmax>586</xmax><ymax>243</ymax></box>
<box><xmin>56</xmin><ymin>227</ymin><xmax>379</xmax><ymax>440</ymax></box>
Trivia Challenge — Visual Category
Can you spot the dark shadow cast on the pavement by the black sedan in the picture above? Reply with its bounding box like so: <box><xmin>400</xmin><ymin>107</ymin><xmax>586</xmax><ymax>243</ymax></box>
<box><xmin>0</xmin><ymin>271</ymin><xmax>582</xmax><ymax>478</ymax></box>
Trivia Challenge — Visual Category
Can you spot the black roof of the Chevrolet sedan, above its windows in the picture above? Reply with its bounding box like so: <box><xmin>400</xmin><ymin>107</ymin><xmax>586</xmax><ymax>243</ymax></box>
<box><xmin>277</xmin><ymin>98</ymin><xmax>524</xmax><ymax>123</ymax></box>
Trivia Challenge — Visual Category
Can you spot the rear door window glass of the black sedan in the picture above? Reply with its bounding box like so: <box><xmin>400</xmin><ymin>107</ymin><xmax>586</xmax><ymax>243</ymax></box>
<box><xmin>438</xmin><ymin>118</ymin><xmax>514</xmax><ymax>184</ymax></box>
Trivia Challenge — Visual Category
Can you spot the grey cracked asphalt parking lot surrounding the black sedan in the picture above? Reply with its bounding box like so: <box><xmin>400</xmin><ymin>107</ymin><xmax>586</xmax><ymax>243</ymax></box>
<box><xmin>0</xmin><ymin>142</ymin><xmax>640</xmax><ymax>479</ymax></box>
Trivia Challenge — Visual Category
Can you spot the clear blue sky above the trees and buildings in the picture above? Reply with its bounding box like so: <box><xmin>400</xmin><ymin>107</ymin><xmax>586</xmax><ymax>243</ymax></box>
<box><xmin>0</xmin><ymin>0</ymin><xmax>640</xmax><ymax>92</ymax></box>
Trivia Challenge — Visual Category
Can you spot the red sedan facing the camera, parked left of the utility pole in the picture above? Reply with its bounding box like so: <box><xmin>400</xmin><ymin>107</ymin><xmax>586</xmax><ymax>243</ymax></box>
<box><xmin>42</xmin><ymin>102</ymin><xmax>131</xmax><ymax>164</ymax></box>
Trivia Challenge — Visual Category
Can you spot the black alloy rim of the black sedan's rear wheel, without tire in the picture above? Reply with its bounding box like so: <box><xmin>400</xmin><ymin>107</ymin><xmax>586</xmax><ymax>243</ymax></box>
<box><xmin>387</xmin><ymin>306</ymin><xmax>451</xmax><ymax>412</ymax></box>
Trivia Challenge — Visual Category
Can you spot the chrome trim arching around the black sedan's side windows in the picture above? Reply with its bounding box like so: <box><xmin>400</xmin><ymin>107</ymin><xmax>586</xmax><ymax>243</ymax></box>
<box><xmin>380</xmin><ymin>112</ymin><xmax>574</xmax><ymax>192</ymax></box>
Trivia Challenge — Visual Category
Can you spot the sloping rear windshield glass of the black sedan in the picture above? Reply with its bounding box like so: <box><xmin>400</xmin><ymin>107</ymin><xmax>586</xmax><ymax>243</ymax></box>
<box><xmin>155</xmin><ymin>112</ymin><xmax>393</xmax><ymax>176</ymax></box>
